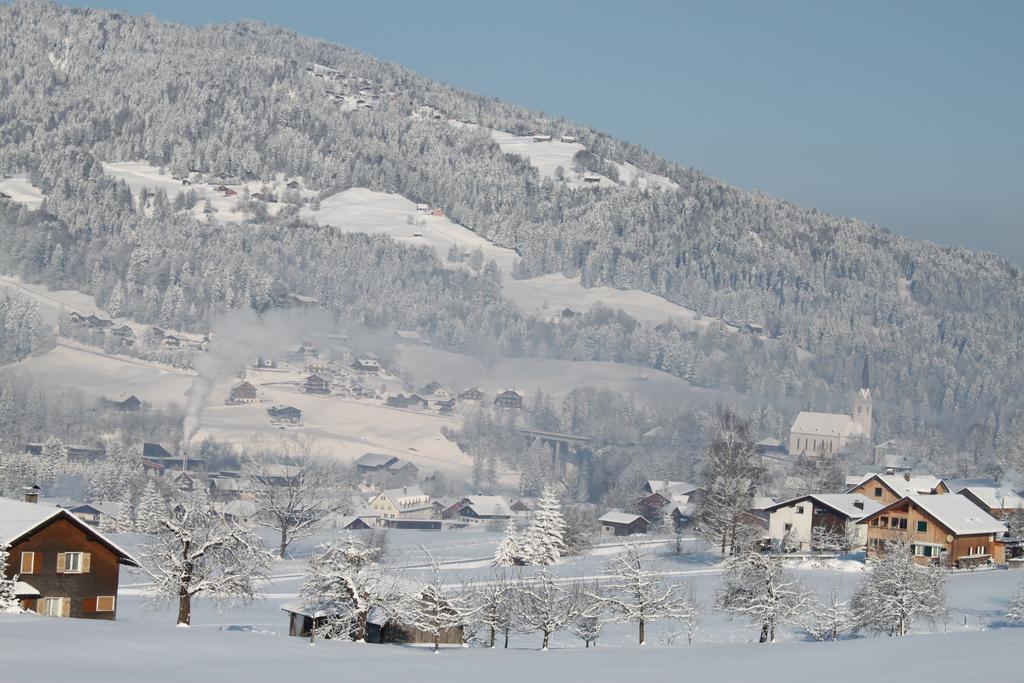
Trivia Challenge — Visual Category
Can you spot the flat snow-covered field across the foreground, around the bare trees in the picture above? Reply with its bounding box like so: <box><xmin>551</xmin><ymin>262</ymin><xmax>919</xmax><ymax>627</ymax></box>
<box><xmin>0</xmin><ymin>529</ymin><xmax>1024</xmax><ymax>683</ymax></box>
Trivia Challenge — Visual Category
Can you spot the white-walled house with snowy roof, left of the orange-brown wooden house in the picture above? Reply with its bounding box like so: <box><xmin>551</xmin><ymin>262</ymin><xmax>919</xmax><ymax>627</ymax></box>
<box><xmin>766</xmin><ymin>494</ymin><xmax>882</xmax><ymax>552</ymax></box>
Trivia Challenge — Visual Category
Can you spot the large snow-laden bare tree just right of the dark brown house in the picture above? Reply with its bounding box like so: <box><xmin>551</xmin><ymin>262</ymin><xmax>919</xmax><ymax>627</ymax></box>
<box><xmin>142</xmin><ymin>497</ymin><xmax>271</xmax><ymax>626</ymax></box>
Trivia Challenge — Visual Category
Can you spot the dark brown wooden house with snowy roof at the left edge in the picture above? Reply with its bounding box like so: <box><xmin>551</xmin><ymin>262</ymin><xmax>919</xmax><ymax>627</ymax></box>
<box><xmin>0</xmin><ymin>499</ymin><xmax>139</xmax><ymax>620</ymax></box>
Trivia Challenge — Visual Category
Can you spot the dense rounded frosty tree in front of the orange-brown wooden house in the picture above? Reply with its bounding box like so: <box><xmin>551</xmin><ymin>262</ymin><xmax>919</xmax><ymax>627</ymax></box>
<box><xmin>853</xmin><ymin>539</ymin><xmax>946</xmax><ymax>636</ymax></box>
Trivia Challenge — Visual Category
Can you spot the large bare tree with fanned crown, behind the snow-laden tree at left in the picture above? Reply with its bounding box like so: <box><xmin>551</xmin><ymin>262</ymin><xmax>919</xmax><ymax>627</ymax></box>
<box><xmin>246</xmin><ymin>454</ymin><xmax>348</xmax><ymax>559</ymax></box>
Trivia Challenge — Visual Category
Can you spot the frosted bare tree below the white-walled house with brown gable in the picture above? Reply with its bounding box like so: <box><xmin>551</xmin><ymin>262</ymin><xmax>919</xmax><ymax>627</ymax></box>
<box><xmin>715</xmin><ymin>551</ymin><xmax>811</xmax><ymax>643</ymax></box>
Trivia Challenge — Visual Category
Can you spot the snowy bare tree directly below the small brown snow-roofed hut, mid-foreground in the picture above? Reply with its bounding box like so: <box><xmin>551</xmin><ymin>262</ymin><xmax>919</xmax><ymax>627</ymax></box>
<box><xmin>603</xmin><ymin>543</ymin><xmax>697</xmax><ymax>645</ymax></box>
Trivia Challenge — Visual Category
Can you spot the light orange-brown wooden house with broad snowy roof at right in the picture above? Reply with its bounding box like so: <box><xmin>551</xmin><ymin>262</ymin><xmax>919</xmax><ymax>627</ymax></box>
<box><xmin>859</xmin><ymin>495</ymin><xmax>1007</xmax><ymax>568</ymax></box>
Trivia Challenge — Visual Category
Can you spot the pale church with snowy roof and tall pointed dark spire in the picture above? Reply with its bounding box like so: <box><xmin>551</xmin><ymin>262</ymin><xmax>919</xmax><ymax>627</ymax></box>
<box><xmin>787</xmin><ymin>357</ymin><xmax>871</xmax><ymax>456</ymax></box>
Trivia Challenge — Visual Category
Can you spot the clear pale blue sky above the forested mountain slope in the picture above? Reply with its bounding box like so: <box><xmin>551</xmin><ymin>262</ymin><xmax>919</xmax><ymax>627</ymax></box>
<box><xmin>64</xmin><ymin>0</ymin><xmax>1024</xmax><ymax>264</ymax></box>
